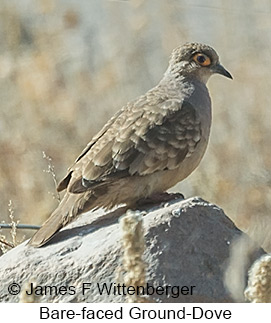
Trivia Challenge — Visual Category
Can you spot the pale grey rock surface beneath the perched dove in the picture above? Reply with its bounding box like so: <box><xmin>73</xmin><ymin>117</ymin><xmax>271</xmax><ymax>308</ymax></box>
<box><xmin>0</xmin><ymin>198</ymin><xmax>262</xmax><ymax>302</ymax></box>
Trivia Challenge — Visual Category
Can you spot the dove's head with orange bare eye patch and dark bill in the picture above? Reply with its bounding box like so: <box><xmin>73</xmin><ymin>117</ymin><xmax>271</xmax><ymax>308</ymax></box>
<box><xmin>167</xmin><ymin>43</ymin><xmax>232</xmax><ymax>83</ymax></box>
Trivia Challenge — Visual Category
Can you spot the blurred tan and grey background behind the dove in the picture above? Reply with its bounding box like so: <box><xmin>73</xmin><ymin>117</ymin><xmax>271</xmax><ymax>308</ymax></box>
<box><xmin>0</xmin><ymin>0</ymin><xmax>271</xmax><ymax>248</ymax></box>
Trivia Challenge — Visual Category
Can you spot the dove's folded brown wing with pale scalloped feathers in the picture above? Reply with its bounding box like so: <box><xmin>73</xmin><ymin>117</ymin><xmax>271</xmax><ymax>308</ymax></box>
<box><xmin>58</xmin><ymin>100</ymin><xmax>201</xmax><ymax>193</ymax></box>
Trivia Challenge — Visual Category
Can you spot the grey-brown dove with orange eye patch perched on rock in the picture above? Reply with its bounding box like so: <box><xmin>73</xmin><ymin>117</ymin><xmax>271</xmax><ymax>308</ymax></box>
<box><xmin>29</xmin><ymin>43</ymin><xmax>232</xmax><ymax>247</ymax></box>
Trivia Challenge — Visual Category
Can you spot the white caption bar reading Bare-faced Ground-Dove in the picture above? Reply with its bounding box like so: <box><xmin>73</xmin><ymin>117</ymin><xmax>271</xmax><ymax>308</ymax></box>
<box><xmin>0</xmin><ymin>303</ymin><xmax>271</xmax><ymax>323</ymax></box>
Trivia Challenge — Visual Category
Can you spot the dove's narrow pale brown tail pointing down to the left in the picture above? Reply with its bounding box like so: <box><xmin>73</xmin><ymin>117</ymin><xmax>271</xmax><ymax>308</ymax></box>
<box><xmin>28</xmin><ymin>193</ymin><xmax>94</xmax><ymax>248</ymax></box>
